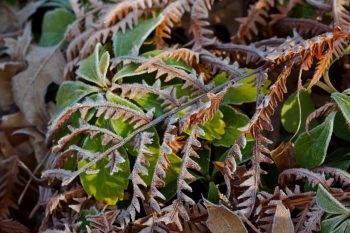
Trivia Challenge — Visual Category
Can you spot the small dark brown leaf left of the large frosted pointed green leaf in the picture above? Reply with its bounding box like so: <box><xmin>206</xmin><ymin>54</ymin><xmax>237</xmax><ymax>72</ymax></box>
<box><xmin>271</xmin><ymin>142</ymin><xmax>297</xmax><ymax>171</ymax></box>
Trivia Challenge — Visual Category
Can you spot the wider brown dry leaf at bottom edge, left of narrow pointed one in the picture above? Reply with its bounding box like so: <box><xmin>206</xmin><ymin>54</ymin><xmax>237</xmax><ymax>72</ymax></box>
<box><xmin>205</xmin><ymin>201</ymin><xmax>248</xmax><ymax>233</ymax></box>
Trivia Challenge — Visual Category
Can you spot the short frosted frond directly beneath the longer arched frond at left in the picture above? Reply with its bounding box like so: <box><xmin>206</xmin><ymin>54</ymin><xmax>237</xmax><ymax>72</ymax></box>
<box><xmin>52</xmin><ymin>119</ymin><xmax>122</xmax><ymax>153</ymax></box>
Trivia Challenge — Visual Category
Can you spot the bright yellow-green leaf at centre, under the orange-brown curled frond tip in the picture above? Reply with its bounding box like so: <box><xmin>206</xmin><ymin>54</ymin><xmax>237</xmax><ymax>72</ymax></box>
<box><xmin>200</xmin><ymin>111</ymin><xmax>225</xmax><ymax>141</ymax></box>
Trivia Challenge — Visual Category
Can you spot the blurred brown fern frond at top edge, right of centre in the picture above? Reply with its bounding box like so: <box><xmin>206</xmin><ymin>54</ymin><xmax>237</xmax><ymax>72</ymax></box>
<box><xmin>231</xmin><ymin>0</ymin><xmax>275</xmax><ymax>43</ymax></box>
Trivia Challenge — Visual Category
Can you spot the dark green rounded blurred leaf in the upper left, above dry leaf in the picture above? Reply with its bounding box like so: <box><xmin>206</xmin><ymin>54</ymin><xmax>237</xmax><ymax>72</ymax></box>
<box><xmin>39</xmin><ymin>9</ymin><xmax>75</xmax><ymax>46</ymax></box>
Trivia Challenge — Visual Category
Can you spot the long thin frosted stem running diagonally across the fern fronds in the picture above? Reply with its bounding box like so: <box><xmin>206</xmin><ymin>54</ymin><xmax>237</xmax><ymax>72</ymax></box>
<box><xmin>62</xmin><ymin>65</ymin><xmax>266</xmax><ymax>186</ymax></box>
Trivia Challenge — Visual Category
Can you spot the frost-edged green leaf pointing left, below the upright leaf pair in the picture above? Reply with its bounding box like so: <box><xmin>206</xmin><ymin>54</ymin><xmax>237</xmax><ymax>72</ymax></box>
<box><xmin>56</xmin><ymin>81</ymin><xmax>100</xmax><ymax>113</ymax></box>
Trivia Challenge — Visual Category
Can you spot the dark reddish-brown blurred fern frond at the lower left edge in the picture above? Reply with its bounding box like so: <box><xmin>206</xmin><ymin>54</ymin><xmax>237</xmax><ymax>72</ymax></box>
<box><xmin>0</xmin><ymin>155</ymin><xmax>20</xmax><ymax>218</ymax></box>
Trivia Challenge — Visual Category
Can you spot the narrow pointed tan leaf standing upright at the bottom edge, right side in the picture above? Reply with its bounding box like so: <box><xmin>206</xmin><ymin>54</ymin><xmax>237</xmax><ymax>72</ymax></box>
<box><xmin>272</xmin><ymin>201</ymin><xmax>294</xmax><ymax>233</ymax></box>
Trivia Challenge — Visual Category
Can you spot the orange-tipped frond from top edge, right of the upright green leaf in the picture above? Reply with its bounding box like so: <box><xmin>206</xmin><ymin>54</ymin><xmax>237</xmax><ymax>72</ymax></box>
<box><xmin>155</xmin><ymin>0</ymin><xmax>195</xmax><ymax>48</ymax></box>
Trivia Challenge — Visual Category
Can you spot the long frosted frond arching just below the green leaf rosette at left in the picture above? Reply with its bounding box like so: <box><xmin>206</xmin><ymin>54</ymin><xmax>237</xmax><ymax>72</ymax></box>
<box><xmin>46</xmin><ymin>96</ymin><xmax>153</xmax><ymax>142</ymax></box>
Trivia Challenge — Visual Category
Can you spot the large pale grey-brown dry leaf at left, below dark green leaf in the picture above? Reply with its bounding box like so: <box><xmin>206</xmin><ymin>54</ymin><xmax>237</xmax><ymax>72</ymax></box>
<box><xmin>12</xmin><ymin>46</ymin><xmax>65</xmax><ymax>132</ymax></box>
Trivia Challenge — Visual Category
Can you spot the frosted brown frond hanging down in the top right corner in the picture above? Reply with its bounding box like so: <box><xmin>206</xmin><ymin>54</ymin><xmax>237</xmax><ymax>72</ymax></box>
<box><xmin>332</xmin><ymin>0</ymin><xmax>350</xmax><ymax>31</ymax></box>
